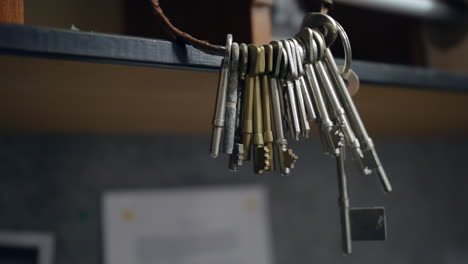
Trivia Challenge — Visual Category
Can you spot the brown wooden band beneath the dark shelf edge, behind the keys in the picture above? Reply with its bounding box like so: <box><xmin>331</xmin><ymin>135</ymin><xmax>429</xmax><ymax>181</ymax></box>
<box><xmin>0</xmin><ymin>54</ymin><xmax>468</xmax><ymax>137</ymax></box>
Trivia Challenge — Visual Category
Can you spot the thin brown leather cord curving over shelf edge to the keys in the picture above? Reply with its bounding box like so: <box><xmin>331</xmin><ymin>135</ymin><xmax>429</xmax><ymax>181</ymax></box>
<box><xmin>151</xmin><ymin>0</ymin><xmax>224</xmax><ymax>56</ymax></box>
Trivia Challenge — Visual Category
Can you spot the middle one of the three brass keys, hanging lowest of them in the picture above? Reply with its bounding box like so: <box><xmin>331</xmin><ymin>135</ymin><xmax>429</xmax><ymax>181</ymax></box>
<box><xmin>249</xmin><ymin>46</ymin><xmax>270</xmax><ymax>174</ymax></box>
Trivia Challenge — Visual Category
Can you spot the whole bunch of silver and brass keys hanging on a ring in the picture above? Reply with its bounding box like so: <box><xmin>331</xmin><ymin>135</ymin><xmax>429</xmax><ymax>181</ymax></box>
<box><xmin>210</xmin><ymin>13</ymin><xmax>392</xmax><ymax>255</ymax></box>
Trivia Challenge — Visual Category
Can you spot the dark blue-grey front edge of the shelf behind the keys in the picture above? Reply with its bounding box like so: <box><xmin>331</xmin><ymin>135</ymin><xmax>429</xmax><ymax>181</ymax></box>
<box><xmin>0</xmin><ymin>23</ymin><xmax>468</xmax><ymax>92</ymax></box>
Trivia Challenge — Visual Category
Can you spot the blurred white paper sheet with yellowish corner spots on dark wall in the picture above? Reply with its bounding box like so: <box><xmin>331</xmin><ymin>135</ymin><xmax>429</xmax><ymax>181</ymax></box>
<box><xmin>103</xmin><ymin>186</ymin><xmax>271</xmax><ymax>264</ymax></box>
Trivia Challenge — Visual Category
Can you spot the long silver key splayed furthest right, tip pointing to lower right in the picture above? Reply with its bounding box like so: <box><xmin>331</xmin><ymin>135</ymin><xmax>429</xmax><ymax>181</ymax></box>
<box><xmin>325</xmin><ymin>49</ymin><xmax>392</xmax><ymax>192</ymax></box>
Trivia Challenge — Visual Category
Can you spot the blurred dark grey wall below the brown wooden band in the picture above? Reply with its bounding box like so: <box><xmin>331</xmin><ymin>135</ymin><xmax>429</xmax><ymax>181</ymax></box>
<box><xmin>0</xmin><ymin>135</ymin><xmax>468</xmax><ymax>264</ymax></box>
